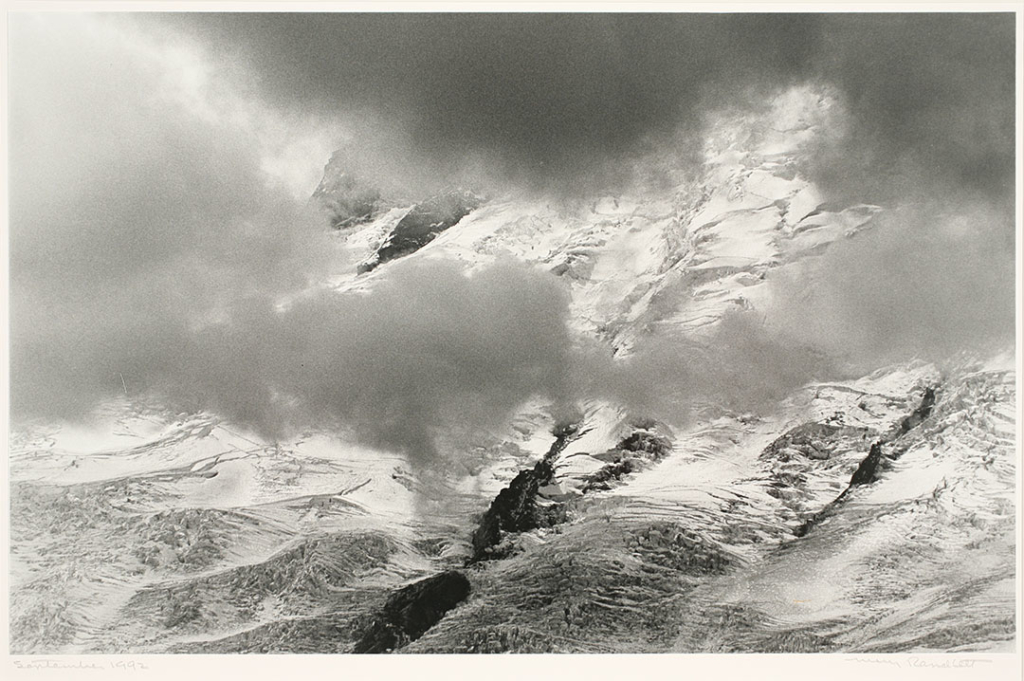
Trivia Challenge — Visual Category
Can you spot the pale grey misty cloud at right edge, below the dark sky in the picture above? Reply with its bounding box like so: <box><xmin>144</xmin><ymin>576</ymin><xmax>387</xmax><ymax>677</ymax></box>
<box><xmin>767</xmin><ymin>203</ymin><xmax>1016</xmax><ymax>373</ymax></box>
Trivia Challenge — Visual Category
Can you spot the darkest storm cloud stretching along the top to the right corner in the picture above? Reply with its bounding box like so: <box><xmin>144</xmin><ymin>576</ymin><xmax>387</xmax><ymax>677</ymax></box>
<box><xmin>149</xmin><ymin>13</ymin><xmax>1015</xmax><ymax>201</ymax></box>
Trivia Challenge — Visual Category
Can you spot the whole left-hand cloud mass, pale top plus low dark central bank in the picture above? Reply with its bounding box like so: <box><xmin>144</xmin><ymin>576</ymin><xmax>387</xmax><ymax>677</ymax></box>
<box><xmin>10</xmin><ymin>17</ymin><xmax>571</xmax><ymax>462</ymax></box>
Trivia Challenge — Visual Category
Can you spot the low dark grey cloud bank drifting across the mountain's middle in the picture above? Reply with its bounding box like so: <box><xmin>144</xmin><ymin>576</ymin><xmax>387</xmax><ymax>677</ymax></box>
<box><xmin>167</xmin><ymin>261</ymin><xmax>572</xmax><ymax>459</ymax></box>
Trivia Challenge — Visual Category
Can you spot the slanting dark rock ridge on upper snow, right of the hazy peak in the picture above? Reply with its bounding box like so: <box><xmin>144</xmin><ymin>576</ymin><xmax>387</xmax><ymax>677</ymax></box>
<box><xmin>359</xmin><ymin>189</ymin><xmax>482</xmax><ymax>272</ymax></box>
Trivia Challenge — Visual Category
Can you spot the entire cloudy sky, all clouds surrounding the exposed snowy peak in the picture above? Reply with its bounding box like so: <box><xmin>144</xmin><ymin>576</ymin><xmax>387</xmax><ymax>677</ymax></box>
<box><xmin>7</xmin><ymin>12</ymin><xmax>1017</xmax><ymax>464</ymax></box>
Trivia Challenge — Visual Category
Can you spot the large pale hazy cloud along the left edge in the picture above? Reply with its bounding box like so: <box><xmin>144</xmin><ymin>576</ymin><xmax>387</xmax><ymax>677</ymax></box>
<box><xmin>10</xmin><ymin>15</ymin><xmax>331</xmax><ymax>416</ymax></box>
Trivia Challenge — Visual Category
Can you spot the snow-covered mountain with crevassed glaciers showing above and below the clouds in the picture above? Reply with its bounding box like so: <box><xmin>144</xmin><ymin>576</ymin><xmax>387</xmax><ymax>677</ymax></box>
<box><xmin>10</xmin><ymin>90</ymin><xmax>1017</xmax><ymax>652</ymax></box>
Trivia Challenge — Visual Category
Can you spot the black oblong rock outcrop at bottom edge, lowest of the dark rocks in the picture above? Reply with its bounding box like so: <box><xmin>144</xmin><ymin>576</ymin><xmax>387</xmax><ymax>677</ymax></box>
<box><xmin>352</xmin><ymin>570</ymin><xmax>470</xmax><ymax>653</ymax></box>
